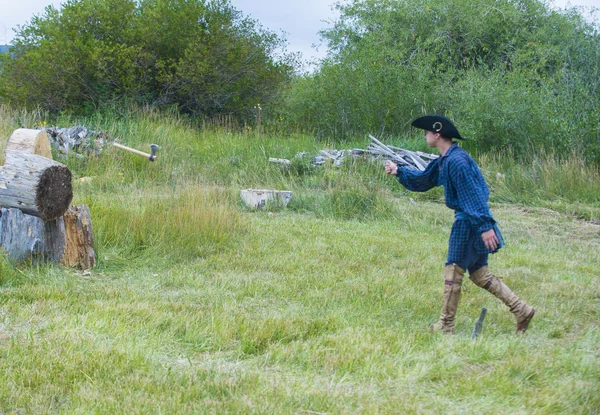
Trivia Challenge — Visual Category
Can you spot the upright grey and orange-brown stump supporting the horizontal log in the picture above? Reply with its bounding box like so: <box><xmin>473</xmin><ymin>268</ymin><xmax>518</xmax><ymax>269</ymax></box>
<box><xmin>0</xmin><ymin>205</ymin><xmax>96</xmax><ymax>269</ymax></box>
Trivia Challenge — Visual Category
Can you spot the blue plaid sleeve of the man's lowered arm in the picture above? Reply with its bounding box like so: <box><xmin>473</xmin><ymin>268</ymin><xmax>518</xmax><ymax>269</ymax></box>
<box><xmin>451</xmin><ymin>163</ymin><xmax>496</xmax><ymax>233</ymax></box>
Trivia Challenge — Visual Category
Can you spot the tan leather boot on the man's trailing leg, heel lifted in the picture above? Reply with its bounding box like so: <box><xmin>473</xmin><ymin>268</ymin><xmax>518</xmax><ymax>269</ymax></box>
<box><xmin>469</xmin><ymin>266</ymin><xmax>535</xmax><ymax>334</ymax></box>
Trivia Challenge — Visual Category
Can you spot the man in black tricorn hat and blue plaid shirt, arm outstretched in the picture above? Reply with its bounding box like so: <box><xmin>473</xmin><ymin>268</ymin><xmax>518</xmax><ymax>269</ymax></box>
<box><xmin>385</xmin><ymin>115</ymin><xmax>535</xmax><ymax>334</ymax></box>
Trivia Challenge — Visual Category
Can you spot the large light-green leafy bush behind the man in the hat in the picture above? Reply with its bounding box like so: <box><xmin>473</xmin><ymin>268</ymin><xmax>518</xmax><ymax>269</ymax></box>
<box><xmin>286</xmin><ymin>0</ymin><xmax>600</xmax><ymax>161</ymax></box>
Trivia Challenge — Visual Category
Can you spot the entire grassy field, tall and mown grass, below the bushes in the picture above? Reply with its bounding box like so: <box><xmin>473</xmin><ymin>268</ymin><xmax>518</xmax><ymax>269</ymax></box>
<box><xmin>0</xmin><ymin>108</ymin><xmax>600</xmax><ymax>414</ymax></box>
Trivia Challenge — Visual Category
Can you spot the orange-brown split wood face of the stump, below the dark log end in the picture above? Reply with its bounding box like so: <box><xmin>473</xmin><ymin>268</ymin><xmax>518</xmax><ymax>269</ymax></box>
<box><xmin>60</xmin><ymin>205</ymin><xmax>96</xmax><ymax>269</ymax></box>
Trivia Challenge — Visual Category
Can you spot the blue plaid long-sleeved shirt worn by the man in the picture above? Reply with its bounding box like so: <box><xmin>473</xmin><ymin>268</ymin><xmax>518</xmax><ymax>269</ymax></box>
<box><xmin>396</xmin><ymin>143</ymin><xmax>504</xmax><ymax>263</ymax></box>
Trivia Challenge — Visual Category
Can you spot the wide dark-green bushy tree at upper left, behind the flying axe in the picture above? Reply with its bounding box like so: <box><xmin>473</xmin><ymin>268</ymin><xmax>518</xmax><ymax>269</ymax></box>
<box><xmin>0</xmin><ymin>0</ymin><xmax>293</xmax><ymax>117</ymax></box>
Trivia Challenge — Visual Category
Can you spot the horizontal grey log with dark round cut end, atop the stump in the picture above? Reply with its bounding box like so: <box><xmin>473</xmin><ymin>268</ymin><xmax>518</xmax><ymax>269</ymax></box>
<box><xmin>0</xmin><ymin>150</ymin><xmax>73</xmax><ymax>221</ymax></box>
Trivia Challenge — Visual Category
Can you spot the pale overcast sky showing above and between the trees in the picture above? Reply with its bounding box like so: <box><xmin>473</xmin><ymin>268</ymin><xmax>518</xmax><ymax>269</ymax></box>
<box><xmin>0</xmin><ymin>0</ymin><xmax>600</xmax><ymax>63</ymax></box>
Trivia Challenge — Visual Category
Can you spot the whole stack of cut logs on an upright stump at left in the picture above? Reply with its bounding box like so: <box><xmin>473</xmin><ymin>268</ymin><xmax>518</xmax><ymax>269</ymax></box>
<box><xmin>0</xmin><ymin>129</ymin><xmax>96</xmax><ymax>269</ymax></box>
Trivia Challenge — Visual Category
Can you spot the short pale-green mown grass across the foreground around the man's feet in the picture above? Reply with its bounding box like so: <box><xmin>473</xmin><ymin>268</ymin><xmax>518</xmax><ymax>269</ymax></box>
<box><xmin>0</xmin><ymin>200</ymin><xmax>600</xmax><ymax>414</ymax></box>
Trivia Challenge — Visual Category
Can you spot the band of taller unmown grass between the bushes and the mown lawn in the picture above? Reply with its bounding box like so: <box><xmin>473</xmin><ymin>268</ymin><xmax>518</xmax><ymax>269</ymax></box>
<box><xmin>0</xmin><ymin>106</ymin><xmax>600</xmax><ymax>270</ymax></box>
